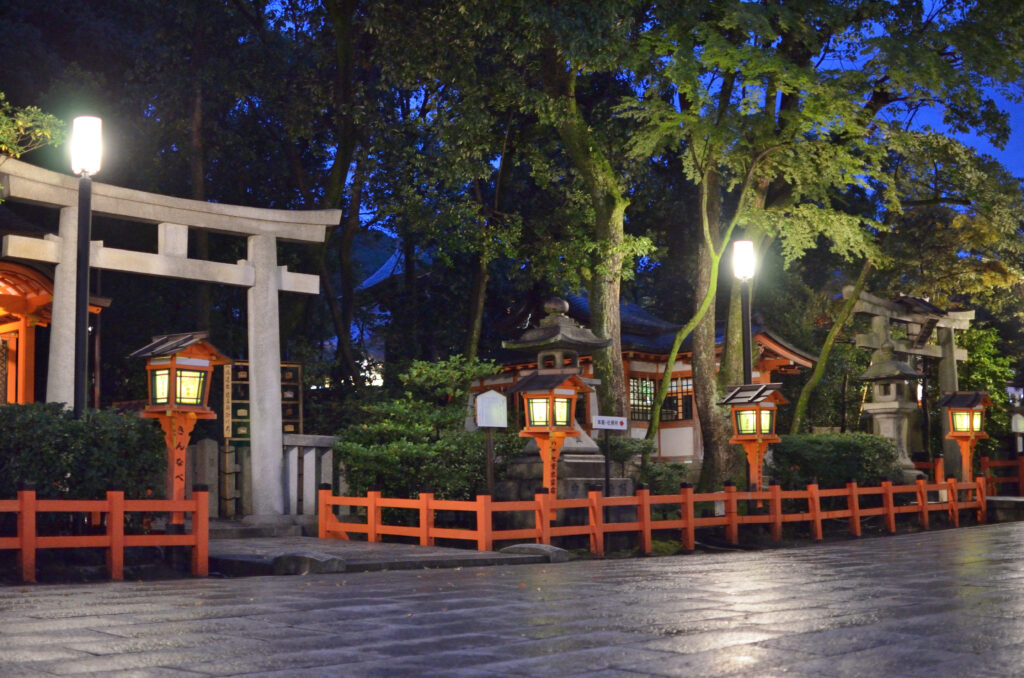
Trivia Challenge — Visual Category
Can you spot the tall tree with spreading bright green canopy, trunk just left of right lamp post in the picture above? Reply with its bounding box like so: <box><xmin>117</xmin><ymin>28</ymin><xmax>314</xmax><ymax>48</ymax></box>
<box><xmin>632</xmin><ymin>1</ymin><xmax>1024</xmax><ymax>486</ymax></box>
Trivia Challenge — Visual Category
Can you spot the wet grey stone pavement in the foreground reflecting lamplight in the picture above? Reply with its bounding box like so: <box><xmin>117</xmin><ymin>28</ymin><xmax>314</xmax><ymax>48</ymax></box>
<box><xmin>6</xmin><ymin>522</ymin><xmax>1024</xmax><ymax>678</ymax></box>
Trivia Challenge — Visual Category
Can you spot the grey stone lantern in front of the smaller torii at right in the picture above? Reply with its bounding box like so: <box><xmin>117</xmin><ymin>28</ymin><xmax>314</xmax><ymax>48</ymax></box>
<box><xmin>859</xmin><ymin>342</ymin><xmax>921</xmax><ymax>479</ymax></box>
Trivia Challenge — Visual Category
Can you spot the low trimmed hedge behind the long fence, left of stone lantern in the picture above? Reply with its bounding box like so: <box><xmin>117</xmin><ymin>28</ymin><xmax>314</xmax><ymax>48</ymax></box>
<box><xmin>765</xmin><ymin>433</ymin><xmax>900</xmax><ymax>490</ymax></box>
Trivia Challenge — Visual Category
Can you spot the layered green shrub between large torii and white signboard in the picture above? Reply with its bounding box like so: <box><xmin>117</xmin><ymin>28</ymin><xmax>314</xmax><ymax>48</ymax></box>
<box><xmin>335</xmin><ymin>355</ymin><xmax>496</xmax><ymax>499</ymax></box>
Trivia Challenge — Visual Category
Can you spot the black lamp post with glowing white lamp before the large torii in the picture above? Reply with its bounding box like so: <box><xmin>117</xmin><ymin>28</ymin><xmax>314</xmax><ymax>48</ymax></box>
<box><xmin>71</xmin><ymin>116</ymin><xmax>103</xmax><ymax>419</ymax></box>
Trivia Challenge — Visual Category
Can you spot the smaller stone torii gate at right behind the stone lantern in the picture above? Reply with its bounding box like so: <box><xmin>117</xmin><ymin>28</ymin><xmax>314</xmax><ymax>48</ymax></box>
<box><xmin>843</xmin><ymin>286</ymin><xmax>974</xmax><ymax>469</ymax></box>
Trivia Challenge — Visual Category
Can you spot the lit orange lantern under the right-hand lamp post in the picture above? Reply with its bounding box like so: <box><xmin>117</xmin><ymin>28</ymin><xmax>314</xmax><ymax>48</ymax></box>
<box><xmin>719</xmin><ymin>383</ymin><xmax>788</xmax><ymax>490</ymax></box>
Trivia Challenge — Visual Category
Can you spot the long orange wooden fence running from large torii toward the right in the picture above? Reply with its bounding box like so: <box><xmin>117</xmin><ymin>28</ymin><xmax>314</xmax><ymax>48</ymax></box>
<box><xmin>318</xmin><ymin>477</ymin><xmax>985</xmax><ymax>555</ymax></box>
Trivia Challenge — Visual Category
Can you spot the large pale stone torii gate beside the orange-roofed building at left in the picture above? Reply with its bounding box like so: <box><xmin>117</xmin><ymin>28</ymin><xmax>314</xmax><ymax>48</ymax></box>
<box><xmin>0</xmin><ymin>158</ymin><xmax>341</xmax><ymax>516</ymax></box>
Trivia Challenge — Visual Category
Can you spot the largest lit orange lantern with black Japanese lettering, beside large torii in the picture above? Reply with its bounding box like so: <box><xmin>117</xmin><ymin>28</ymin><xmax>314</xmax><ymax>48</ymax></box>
<box><xmin>131</xmin><ymin>332</ymin><xmax>230</xmax><ymax>524</ymax></box>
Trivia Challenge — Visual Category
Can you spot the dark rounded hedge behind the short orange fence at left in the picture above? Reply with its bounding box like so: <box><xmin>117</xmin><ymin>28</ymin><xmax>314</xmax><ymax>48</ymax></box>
<box><xmin>0</xmin><ymin>404</ymin><xmax>167</xmax><ymax>499</ymax></box>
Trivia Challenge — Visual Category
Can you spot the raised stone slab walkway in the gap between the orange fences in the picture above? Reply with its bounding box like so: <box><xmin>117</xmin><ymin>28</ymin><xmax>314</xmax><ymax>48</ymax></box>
<box><xmin>210</xmin><ymin>537</ymin><xmax>552</xmax><ymax>577</ymax></box>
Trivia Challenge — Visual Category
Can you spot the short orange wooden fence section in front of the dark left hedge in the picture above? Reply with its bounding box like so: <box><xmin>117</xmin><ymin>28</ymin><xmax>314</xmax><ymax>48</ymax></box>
<box><xmin>0</xmin><ymin>488</ymin><xmax>210</xmax><ymax>582</ymax></box>
